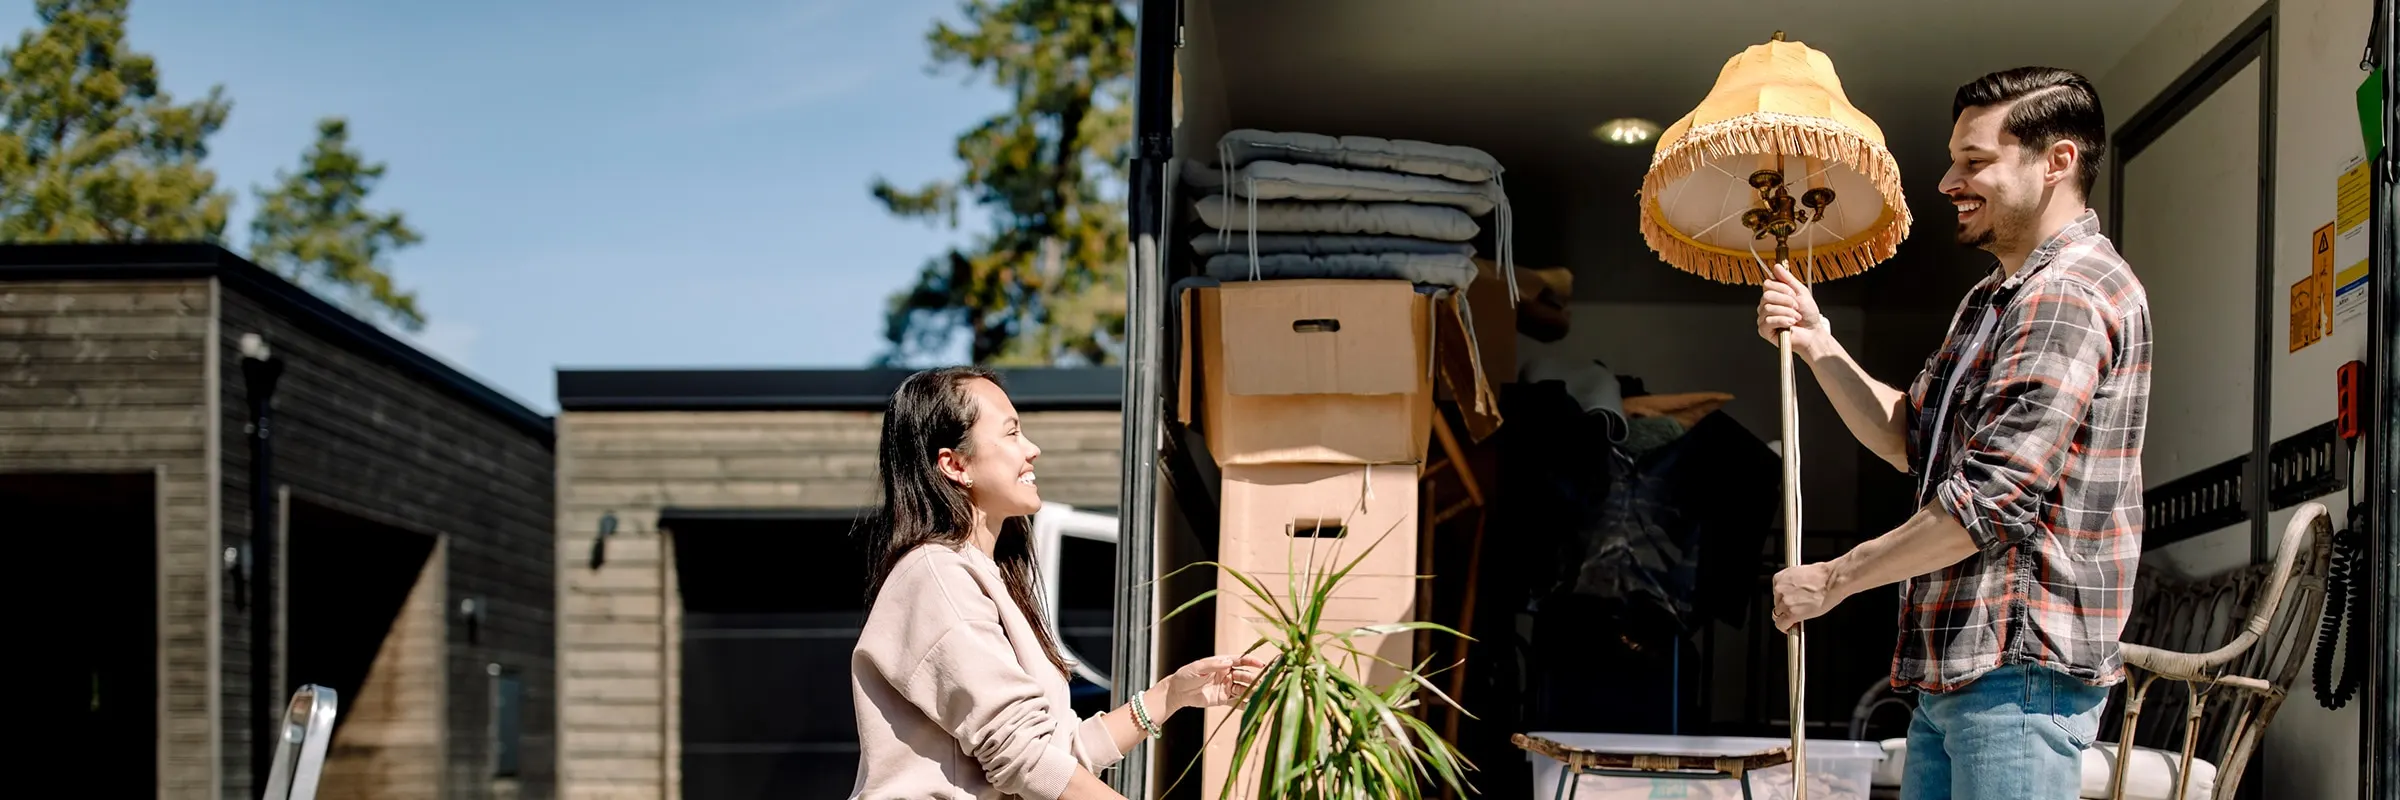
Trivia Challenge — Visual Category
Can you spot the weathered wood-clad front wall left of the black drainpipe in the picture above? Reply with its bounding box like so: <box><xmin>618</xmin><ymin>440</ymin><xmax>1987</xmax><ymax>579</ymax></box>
<box><xmin>0</xmin><ymin>279</ymin><xmax>218</xmax><ymax>798</ymax></box>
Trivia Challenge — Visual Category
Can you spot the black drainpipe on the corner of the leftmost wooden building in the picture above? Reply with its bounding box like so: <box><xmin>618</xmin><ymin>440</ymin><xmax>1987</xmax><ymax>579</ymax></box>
<box><xmin>242</xmin><ymin>345</ymin><xmax>283</xmax><ymax>793</ymax></box>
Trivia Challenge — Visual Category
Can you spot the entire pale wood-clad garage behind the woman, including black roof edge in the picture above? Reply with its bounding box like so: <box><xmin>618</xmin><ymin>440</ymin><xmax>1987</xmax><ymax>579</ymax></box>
<box><xmin>557</xmin><ymin>368</ymin><xmax>1123</xmax><ymax>800</ymax></box>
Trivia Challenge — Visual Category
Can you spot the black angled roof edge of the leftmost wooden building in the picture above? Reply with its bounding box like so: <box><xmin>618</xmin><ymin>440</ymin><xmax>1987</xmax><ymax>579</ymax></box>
<box><xmin>0</xmin><ymin>243</ymin><xmax>554</xmax><ymax>444</ymax></box>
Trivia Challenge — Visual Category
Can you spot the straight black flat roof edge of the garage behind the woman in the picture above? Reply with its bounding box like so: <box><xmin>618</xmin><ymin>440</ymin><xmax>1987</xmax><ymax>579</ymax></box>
<box><xmin>557</xmin><ymin>368</ymin><xmax>1126</xmax><ymax>411</ymax></box>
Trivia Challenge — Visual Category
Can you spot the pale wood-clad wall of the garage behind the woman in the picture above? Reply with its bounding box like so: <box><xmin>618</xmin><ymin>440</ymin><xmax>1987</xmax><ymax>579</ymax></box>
<box><xmin>557</xmin><ymin>401</ymin><xmax>1123</xmax><ymax>800</ymax></box>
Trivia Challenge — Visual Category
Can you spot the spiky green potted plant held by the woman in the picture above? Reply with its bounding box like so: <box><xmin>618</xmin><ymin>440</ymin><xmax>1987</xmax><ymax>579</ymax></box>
<box><xmin>1162</xmin><ymin>521</ymin><xmax>1474</xmax><ymax>800</ymax></box>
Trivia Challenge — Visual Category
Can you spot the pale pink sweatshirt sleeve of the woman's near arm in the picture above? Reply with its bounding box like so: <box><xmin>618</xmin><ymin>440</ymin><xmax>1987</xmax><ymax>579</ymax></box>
<box><xmin>898</xmin><ymin>559</ymin><xmax>1075</xmax><ymax>798</ymax></box>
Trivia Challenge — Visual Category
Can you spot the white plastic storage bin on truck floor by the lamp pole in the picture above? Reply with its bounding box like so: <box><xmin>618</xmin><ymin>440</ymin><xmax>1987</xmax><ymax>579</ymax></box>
<box><xmin>1524</xmin><ymin>733</ymin><xmax>1884</xmax><ymax>800</ymax></box>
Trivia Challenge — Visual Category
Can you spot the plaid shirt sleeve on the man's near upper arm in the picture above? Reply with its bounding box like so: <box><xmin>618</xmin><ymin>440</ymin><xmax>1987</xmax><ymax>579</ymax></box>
<box><xmin>1934</xmin><ymin>281</ymin><xmax>2112</xmax><ymax>553</ymax></box>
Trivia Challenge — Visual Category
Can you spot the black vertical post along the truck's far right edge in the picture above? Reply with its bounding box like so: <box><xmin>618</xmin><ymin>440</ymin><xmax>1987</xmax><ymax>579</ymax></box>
<box><xmin>2352</xmin><ymin>0</ymin><xmax>2400</xmax><ymax>800</ymax></box>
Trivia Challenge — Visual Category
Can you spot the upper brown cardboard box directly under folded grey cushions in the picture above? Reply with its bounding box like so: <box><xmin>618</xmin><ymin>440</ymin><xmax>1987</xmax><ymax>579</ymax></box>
<box><xmin>1178</xmin><ymin>279</ymin><xmax>1435</xmax><ymax>466</ymax></box>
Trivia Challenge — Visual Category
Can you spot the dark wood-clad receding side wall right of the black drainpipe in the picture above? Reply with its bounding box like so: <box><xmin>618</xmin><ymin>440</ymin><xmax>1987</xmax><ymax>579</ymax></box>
<box><xmin>218</xmin><ymin>286</ymin><xmax>559</xmax><ymax>800</ymax></box>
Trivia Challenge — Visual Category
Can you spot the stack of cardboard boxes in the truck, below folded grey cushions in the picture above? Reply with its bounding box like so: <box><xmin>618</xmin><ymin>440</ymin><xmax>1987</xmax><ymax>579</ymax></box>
<box><xmin>1181</xmin><ymin>279</ymin><xmax>1457</xmax><ymax>795</ymax></box>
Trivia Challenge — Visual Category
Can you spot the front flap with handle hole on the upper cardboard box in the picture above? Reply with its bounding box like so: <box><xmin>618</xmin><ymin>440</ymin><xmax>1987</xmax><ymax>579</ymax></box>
<box><xmin>1217</xmin><ymin>281</ymin><xmax>1423</xmax><ymax>396</ymax></box>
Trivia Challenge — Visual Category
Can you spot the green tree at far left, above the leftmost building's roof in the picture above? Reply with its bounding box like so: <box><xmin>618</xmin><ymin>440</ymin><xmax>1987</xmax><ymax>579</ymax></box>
<box><xmin>0</xmin><ymin>0</ymin><xmax>233</xmax><ymax>243</ymax></box>
